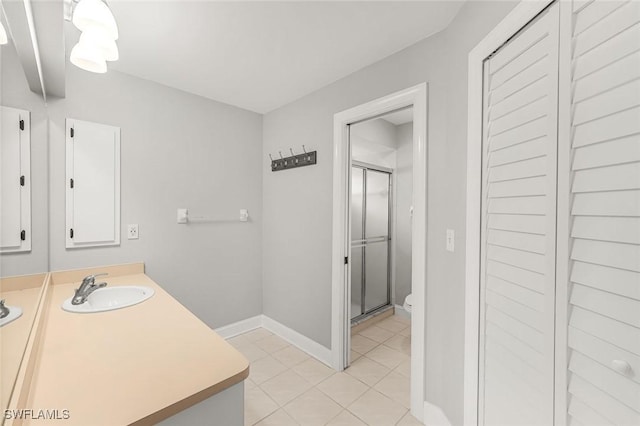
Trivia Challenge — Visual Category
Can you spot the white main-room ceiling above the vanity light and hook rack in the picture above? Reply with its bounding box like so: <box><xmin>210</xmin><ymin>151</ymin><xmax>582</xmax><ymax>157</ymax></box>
<box><xmin>67</xmin><ymin>0</ymin><xmax>462</xmax><ymax>113</ymax></box>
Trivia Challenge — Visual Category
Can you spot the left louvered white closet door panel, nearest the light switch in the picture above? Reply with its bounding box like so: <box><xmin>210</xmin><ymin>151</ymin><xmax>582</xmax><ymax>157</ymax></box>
<box><xmin>479</xmin><ymin>4</ymin><xmax>559</xmax><ymax>426</ymax></box>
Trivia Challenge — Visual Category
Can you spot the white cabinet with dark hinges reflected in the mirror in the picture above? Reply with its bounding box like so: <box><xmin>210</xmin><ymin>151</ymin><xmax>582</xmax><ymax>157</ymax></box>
<box><xmin>0</xmin><ymin>106</ymin><xmax>31</xmax><ymax>253</ymax></box>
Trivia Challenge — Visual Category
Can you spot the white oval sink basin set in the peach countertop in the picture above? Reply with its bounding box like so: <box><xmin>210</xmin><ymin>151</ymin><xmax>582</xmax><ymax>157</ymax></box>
<box><xmin>62</xmin><ymin>285</ymin><xmax>154</xmax><ymax>314</ymax></box>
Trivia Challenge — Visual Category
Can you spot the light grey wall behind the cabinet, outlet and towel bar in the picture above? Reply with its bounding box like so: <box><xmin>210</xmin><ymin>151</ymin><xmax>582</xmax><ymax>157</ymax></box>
<box><xmin>49</xmin><ymin>65</ymin><xmax>268</xmax><ymax>328</ymax></box>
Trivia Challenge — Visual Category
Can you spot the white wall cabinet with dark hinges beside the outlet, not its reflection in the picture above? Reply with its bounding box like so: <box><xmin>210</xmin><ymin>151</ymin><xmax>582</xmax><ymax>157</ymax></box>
<box><xmin>65</xmin><ymin>119</ymin><xmax>120</xmax><ymax>248</ymax></box>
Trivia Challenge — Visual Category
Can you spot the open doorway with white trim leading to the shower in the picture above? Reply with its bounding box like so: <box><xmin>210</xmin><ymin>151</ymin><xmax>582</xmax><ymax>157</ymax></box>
<box><xmin>332</xmin><ymin>84</ymin><xmax>427</xmax><ymax>420</ymax></box>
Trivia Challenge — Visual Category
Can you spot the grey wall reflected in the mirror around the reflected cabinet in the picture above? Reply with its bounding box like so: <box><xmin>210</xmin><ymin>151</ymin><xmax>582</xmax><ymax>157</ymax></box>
<box><xmin>0</xmin><ymin>43</ymin><xmax>49</xmax><ymax>277</ymax></box>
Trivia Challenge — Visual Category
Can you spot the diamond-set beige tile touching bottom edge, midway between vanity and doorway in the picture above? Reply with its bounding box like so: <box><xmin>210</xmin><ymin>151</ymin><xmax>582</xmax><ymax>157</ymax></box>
<box><xmin>284</xmin><ymin>388</ymin><xmax>342</xmax><ymax>426</ymax></box>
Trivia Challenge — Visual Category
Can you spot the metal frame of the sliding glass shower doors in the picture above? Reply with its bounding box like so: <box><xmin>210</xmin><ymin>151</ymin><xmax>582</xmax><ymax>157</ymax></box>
<box><xmin>350</xmin><ymin>160</ymin><xmax>393</xmax><ymax>322</ymax></box>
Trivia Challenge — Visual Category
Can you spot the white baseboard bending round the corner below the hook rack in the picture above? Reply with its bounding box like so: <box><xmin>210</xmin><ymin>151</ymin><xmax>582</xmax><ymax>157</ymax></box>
<box><xmin>215</xmin><ymin>315</ymin><xmax>333</xmax><ymax>368</ymax></box>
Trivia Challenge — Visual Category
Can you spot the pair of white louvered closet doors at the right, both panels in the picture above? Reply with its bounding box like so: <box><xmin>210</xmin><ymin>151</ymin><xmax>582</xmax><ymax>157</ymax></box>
<box><xmin>478</xmin><ymin>0</ymin><xmax>640</xmax><ymax>426</ymax></box>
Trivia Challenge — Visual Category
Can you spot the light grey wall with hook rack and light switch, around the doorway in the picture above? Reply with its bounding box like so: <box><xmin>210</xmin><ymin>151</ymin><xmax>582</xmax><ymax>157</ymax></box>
<box><xmin>263</xmin><ymin>1</ymin><xmax>516</xmax><ymax>424</ymax></box>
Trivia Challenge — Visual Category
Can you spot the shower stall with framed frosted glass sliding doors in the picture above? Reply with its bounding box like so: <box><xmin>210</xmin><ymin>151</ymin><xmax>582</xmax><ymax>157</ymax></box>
<box><xmin>351</xmin><ymin>161</ymin><xmax>392</xmax><ymax>324</ymax></box>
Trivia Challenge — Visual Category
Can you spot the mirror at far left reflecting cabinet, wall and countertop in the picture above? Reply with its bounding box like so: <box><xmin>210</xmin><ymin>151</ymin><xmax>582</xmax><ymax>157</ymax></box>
<box><xmin>0</xmin><ymin>31</ymin><xmax>49</xmax><ymax>418</ymax></box>
